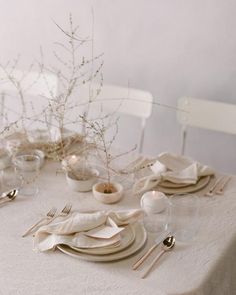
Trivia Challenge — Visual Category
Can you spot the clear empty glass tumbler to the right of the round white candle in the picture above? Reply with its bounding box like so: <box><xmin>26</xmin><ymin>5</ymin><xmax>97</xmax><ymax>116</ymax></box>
<box><xmin>169</xmin><ymin>194</ymin><xmax>200</xmax><ymax>242</ymax></box>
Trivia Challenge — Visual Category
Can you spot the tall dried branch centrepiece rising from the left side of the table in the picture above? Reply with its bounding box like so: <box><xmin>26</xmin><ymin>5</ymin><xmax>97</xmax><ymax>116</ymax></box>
<box><xmin>0</xmin><ymin>15</ymin><xmax>158</xmax><ymax>194</ymax></box>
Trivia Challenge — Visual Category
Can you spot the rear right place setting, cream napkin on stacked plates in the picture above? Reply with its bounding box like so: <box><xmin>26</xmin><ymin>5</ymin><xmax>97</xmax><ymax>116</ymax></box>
<box><xmin>133</xmin><ymin>152</ymin><xmax>215</xmax><ymax>195</ymax></box>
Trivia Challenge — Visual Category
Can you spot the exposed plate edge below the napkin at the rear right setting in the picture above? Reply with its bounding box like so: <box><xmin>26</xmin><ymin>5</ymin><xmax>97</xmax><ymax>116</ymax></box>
<box><xmin>157</xmin><ymin>176</ymin><xmax>211</xmax><ymax>195</ymax></box>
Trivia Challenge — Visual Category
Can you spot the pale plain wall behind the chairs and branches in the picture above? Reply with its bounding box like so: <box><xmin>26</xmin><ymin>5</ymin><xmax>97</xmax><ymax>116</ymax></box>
<box><xmin>0</xmin><ymin>0</ymin><xmax>236</xmax><ymax>173</ymax></box>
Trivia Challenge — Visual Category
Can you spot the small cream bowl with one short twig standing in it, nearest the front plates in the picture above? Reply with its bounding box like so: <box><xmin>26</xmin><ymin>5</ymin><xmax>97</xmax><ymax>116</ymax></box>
<box><xmin>93</xmin><ymin>182</ymin><xmax>124</xmax><ymax>204</ymax></box>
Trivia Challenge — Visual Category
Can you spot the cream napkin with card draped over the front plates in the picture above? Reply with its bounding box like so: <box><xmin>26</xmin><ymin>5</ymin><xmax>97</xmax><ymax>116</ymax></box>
<box><xmin>34</xmin><ymin>210</ymin><xmax>142</xmax><ymax>251</ymax></box>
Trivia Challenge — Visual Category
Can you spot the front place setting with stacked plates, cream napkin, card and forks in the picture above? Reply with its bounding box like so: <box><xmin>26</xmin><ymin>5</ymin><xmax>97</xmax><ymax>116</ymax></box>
<box><xmin>22</xmin><ymin>205</ymin><xmax>147</xmax><ymax>262</ymax></box>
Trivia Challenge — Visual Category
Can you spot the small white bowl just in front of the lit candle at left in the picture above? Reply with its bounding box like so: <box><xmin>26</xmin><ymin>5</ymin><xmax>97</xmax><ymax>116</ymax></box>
<box><xmin>66</xmin><ymin>169</ymin><xmax>99</xmax><ymax>192</ymax></box>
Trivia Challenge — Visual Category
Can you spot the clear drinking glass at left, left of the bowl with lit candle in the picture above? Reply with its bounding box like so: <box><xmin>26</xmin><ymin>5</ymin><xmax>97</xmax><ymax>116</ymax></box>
<box><xmin>14</xmin><ymin>154</ymin><xmax>41</xmax><ymax>196</ymax></box>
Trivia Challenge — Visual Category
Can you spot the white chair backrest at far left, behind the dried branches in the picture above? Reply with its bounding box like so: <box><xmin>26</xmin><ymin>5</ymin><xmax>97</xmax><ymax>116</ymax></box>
<box><xmin>0</xmin><ymin>69</ymin><xmax>58</xmax><ymax>132</ymax></box>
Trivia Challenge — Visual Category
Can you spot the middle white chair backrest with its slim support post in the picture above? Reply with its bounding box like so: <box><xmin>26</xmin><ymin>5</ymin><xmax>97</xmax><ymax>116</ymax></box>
<box><xmin>77</xmin><ymin>84</ymin><xmax>153</xmax><ymax>152</ymax></box>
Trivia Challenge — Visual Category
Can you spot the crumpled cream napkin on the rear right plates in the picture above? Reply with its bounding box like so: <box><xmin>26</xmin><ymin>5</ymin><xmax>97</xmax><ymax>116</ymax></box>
<box><xmin>133</xmin><ymin>153</ymin><xmax>214</xmax><ymax>193</ymax></box>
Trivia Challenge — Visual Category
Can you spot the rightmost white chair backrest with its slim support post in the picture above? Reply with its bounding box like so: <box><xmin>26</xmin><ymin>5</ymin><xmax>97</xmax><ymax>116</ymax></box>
<box><xmin>177</xmin><ymin>97</ymin><xmax>236</xmax><ymax>154</ymax></box>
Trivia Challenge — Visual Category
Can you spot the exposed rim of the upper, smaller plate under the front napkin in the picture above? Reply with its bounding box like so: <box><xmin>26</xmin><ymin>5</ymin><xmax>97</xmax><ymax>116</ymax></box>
<box><xmin>70</xmin><ymin>225</ymin><xmax>135</xmax><ymax>255</ymax></box>
